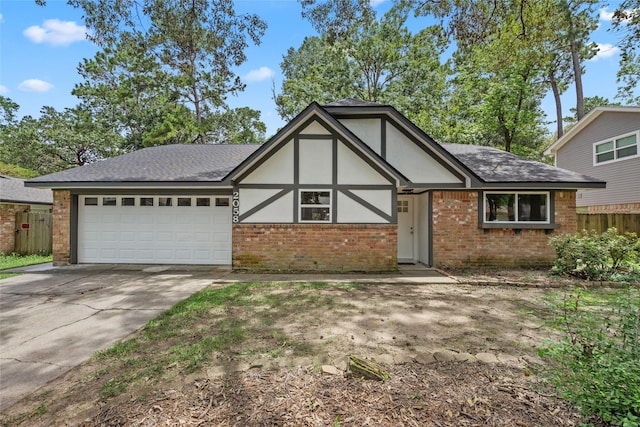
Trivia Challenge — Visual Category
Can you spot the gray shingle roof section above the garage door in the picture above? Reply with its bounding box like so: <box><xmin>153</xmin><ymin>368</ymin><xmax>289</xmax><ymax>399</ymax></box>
<box><xmin>29</xmin><ymin>144</ymin><xmax>260</xmax><ymax>183</ymax></box>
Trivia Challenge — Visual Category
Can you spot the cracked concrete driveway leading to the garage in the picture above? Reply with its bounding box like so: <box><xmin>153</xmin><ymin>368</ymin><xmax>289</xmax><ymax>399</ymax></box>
<box><xmin>0</xmin><ymin>265</ymin><xmax>221</xmax><ymax>410</ymax></box>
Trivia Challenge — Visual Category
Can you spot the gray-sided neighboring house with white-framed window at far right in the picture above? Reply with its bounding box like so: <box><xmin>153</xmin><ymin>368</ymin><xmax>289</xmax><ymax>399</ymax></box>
<box><xmin>545</xmin><ymin>107</ymin><xmax>640</xmax><ymax>213</ymax></box>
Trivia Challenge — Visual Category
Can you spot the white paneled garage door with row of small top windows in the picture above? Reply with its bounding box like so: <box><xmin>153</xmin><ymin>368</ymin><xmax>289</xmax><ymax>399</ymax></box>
<box><xmin>78</xmin><ymin>196</ymin><xmax>231</xmax><ymax>264</ymax></box>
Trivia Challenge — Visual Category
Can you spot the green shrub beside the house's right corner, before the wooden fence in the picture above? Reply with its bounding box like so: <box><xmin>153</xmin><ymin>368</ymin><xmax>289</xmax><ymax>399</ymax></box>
<box><xmin>550</xmin><ymin>228</ymin><xmax>640</xmax><ymax>280</ymax></box>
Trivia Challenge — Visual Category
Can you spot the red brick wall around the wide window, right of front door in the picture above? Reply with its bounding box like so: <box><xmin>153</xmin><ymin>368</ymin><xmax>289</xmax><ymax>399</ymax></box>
<box><xmin>432</xmin><ymin>191</ymin><xmax>576</xmax><ymax>267</ymax></box>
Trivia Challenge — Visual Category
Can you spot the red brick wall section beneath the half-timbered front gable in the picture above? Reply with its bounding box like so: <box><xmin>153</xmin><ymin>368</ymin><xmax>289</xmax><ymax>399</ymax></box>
<box><xmin>233</xmin><ymin>224</ymin><xmax>398</xmax><ymax>272</ymax></box>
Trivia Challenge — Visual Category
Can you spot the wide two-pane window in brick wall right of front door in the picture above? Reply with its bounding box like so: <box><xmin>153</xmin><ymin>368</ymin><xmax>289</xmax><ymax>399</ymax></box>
<box><xmin>484</xmin><ymin>192</ymin><xmax>550</xmax><ymax>223</ymax></box>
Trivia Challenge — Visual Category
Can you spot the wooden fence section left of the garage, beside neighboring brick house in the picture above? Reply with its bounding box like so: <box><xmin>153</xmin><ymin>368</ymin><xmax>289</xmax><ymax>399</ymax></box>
<box><xmin>15</xmin><ymin>212</ymin><xmax>53</xmax><ymax>255</ymax></box>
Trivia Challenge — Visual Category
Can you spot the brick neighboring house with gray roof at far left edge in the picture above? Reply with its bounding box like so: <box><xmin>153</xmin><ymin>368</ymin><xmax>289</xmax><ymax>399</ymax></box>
<box><xmin>0</xmin><ymin>175</ymin><xmax>53</xmax><ymax>254</ymax></box>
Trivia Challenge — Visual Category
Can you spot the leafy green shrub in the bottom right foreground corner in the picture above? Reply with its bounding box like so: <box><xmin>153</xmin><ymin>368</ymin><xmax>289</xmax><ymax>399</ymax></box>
<box><xmin>539</xmin><ymin>288</ymin><xmax>640</xmax><ymax>427</ymax></box>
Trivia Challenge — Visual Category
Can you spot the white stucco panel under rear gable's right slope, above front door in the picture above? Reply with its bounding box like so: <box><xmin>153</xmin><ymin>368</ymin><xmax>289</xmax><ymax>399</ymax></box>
<box><xmin>387</xmin><ymin>124</ymin><xmax>461</xmax><ymax>183</ymax></box>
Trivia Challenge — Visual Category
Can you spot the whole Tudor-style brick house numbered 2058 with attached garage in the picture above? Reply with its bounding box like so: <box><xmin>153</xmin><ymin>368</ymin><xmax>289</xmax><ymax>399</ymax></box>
<box><xmin>27</xmin><ymin>100</ymin><xmax>604</xmax><ymax>271</ymax></box>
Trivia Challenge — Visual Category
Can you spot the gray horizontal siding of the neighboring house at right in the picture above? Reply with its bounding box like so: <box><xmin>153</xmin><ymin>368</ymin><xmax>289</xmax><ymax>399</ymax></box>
<box><xmin>556</xmin><ymin>112</ymin><xmax>640</xmax><ymax>207</ymax></box>
